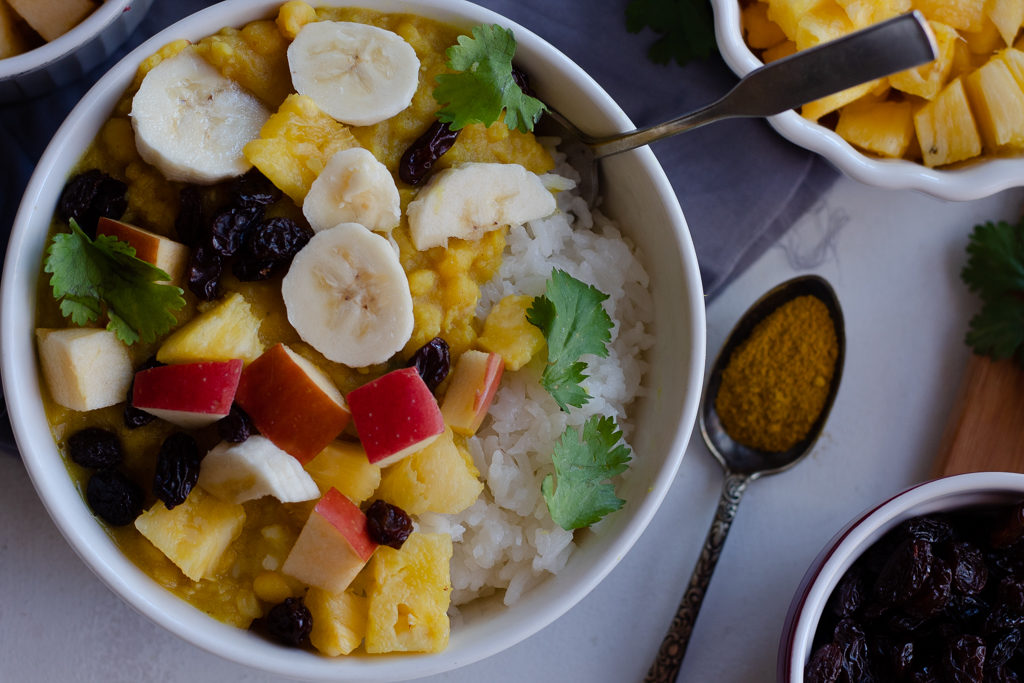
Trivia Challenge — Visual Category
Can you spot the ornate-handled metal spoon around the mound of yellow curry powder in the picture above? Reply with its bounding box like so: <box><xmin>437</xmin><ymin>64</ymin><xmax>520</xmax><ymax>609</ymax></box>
<box><xmin>644</xmin><ymin>275</ymin><xmax>846</xmax><ymax>683</ymax></box>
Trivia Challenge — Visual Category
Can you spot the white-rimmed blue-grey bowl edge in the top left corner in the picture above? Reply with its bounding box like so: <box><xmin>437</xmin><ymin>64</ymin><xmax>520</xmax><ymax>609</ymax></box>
<box><xmin>0</xmin><ymin>0</ymin><xmax>153</xmax><ymax>103</ymax></box>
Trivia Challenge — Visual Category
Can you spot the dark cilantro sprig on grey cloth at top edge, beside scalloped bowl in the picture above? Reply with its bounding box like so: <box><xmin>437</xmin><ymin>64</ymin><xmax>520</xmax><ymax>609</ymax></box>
<box><xmin>626</xmin><ymin>0</ymin><xmax>717</xmax><ymax>67</ymax></box>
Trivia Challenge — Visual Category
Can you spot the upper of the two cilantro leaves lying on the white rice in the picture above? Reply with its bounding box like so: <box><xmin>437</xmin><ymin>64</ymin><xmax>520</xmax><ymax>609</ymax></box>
<box><xmin>526</xmin><ymin>269</ymin><xmax>612</xmax><ymax>413</ymax></box>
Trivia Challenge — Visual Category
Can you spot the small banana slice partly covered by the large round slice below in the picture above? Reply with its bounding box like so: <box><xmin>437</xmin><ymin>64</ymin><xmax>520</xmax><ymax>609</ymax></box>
<box><xmin>302</xmin><ymin>147</ymin><xmax>401</xmax><ymax>234</ymax></box>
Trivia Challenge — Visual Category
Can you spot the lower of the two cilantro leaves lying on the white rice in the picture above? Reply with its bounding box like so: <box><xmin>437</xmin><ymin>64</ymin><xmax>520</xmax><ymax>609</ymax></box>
<box><xmin>541</xmin><ymin>415</ymin><xmax>630</xmax><ymax>531</ymax></box>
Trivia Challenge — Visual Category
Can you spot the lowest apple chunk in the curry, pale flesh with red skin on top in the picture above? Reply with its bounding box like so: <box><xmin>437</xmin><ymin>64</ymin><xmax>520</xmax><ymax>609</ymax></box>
<box><xmin>281</xmin><ymin>488</ymin><xmax>377</xmax><ymax>593</ymax></box>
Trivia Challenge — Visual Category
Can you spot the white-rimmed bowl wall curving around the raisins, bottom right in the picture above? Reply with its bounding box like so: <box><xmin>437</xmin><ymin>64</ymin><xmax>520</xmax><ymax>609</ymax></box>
<box><xmin>776</xmin><ymin>472</ymin><xmax>1024</xmax><ymax>683</ymax></box>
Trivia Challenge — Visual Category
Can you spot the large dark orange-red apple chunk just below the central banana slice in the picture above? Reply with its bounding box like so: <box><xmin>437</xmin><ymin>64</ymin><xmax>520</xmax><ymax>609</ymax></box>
<box><xmin>237</xmin><ymin>344</ymin><xmax>351</xmax><ymax>465</ymax></box>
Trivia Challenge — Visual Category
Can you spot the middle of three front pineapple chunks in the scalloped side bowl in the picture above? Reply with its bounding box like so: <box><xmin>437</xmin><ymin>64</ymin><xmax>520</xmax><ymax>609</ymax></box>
<box><xmin>913</xmin><ymin>79</ymin><xmax>981</xmax><ymax>168</ymax></box>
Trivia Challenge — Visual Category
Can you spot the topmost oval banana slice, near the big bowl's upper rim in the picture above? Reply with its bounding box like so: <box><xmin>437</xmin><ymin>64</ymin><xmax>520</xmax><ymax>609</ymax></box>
<box><xmin>288</xmin><ymin>22</ymin><xmax>420</xmax><ymax>126</ymax></box>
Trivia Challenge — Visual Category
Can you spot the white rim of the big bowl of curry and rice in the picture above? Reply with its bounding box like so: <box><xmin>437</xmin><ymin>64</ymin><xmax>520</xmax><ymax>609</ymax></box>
<box><xmin>0</xmin><ymin>0</ymin><xmax>706</xmax><ymax>681</ymax></box>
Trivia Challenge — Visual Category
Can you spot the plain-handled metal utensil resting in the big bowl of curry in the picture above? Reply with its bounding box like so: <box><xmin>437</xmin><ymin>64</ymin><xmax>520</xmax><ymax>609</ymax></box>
<box><xmin>538</xmin><ymin>10</ymin><xmax>938</xmax><ymax>205</ymax></box>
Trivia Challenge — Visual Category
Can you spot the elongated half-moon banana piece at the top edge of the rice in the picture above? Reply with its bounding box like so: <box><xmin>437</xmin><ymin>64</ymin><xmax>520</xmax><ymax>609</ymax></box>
<box><xmin>406</xmin><ymin>163</ymin><xmax>556</xmax><ymax>251</ymax></box>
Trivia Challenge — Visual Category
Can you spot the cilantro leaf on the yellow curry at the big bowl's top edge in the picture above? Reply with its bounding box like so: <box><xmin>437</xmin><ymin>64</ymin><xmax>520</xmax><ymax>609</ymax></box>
<box><xmin>433</xmin><ymin>25</ymin><xmax>547</xmax><ymax>133</ymax></box>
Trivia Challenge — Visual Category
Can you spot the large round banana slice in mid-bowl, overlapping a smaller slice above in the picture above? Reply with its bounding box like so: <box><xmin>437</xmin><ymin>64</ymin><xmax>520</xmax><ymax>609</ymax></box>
<box><xmin>281</xmin><ymin>223</ymin><xmax>413</xmax><ymax>368</ymax></box>
